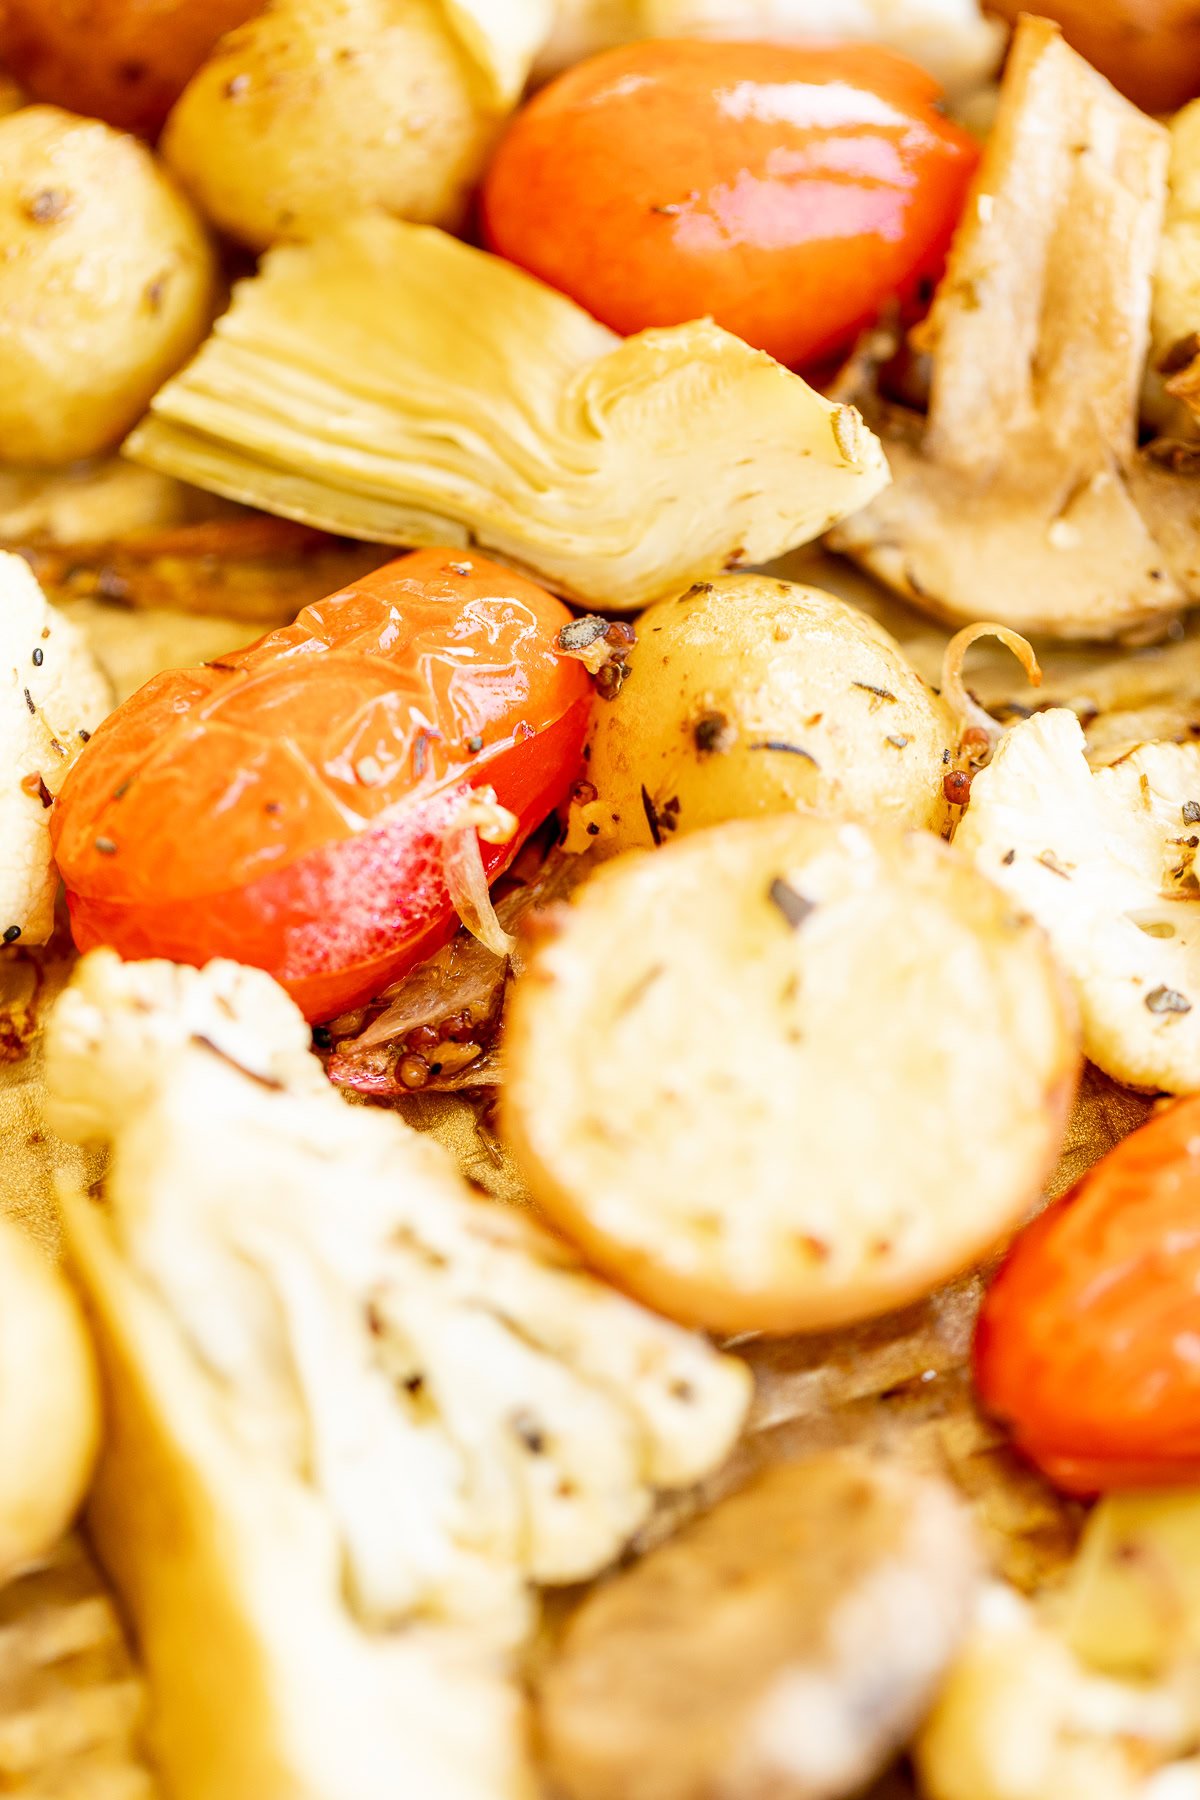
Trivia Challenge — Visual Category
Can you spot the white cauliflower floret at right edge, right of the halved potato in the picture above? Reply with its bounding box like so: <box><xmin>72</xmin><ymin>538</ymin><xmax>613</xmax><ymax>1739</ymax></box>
<box><xmin>955</xmin><ymin>707</ymin><xmax>1200</xmax><ymax>1093</ymax></box>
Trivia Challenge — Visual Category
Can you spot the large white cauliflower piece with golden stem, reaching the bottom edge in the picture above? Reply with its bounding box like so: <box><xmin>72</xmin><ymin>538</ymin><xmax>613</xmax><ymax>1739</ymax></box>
<box><xmin>47</xmin><ymin>952</ymin><xmax>748</xmax><ymax>1800</ymax></box>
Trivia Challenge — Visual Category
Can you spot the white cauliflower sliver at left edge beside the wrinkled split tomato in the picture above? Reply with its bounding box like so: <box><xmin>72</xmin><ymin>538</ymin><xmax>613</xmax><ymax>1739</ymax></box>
<box><xmin>0</xmin><ymin>553</ymin><xmax>110</xmax><ymax>943</ymax></box>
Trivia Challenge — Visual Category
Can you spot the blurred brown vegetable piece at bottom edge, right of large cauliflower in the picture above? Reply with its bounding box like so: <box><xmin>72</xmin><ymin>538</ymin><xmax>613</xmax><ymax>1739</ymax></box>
<box><xmin>540</xmin><ymin>1451</ymin><xmax>975</xmax><ymax>1800</ymax></box>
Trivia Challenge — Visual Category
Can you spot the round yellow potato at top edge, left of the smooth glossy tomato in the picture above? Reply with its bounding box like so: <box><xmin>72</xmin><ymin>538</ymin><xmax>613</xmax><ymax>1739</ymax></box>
<box><xmin>162</xmin><ymin>0</ymin><xmax>500</xmax><ymax>250</ymax></box>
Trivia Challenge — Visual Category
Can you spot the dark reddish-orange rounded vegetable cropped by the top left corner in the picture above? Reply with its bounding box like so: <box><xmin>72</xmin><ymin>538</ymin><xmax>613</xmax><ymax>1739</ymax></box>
<box><xmin>0</xmin><ymin>0</ymin><xmax>263</xmax><ymax>137</ymax></box>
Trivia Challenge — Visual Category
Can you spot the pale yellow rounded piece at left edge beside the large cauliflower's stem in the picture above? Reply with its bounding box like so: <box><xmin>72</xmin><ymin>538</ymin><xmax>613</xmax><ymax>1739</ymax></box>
<box><xmin>0</xmin><ymin>1215</ymin><xmax>99</xmax><ymax>1582</ymax></box>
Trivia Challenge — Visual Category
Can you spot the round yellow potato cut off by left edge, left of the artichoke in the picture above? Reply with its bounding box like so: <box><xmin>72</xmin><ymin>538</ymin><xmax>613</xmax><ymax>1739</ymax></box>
<box><xmin>0</xmin><ymin>106</ymin><xmax>216</xmax><ymax>464</ymax></box>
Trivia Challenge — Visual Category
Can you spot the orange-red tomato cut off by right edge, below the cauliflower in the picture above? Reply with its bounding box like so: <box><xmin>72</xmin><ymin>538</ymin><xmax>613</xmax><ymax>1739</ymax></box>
<box><xmin>975</xmin><ymin>1096</ymin><xmax>1200</xmax><ymax>1494</ymax></box>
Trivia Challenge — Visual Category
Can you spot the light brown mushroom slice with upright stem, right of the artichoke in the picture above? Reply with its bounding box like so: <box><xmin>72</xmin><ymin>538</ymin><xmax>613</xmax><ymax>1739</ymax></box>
<box><xmin>835</xmin><ymin>18</ymin><xmax>1200</xmax><ymax>637</ymax></box>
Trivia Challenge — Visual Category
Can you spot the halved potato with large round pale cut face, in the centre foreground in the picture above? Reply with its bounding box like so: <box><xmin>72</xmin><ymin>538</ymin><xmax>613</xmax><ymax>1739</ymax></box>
<box><xmin>502</xmin><ymin>815</ymin><xmax>1076</xmax><ymax>1332</ymax></box>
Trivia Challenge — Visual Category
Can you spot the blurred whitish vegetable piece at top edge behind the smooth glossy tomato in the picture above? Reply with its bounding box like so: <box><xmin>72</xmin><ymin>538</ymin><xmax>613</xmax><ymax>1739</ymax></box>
<box><xmin>538</xmin><ymin>0</ymin><xmax>1004</xmax><ymax>97</ymax></box>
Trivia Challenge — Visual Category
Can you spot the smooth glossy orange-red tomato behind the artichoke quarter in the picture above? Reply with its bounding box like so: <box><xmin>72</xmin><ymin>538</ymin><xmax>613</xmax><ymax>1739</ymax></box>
<box><xmin>482</xmin><ymin>41</ymin><xmax>979</xmax><ymax>365</ymax></box>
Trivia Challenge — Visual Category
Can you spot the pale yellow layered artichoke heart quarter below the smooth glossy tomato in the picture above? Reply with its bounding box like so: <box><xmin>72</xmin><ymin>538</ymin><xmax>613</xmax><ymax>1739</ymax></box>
<box><xmin>126</xmin><ymin>216</ymin><xmax>889</xmax><ymax>608</ymax></box>
